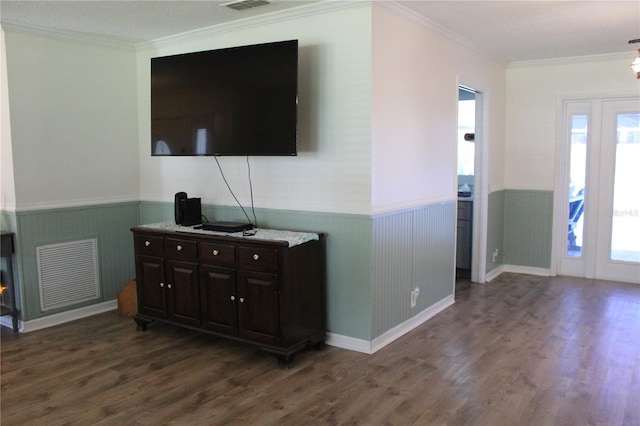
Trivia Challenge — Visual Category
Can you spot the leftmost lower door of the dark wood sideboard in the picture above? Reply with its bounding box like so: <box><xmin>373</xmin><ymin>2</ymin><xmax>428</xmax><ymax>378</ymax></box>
<box><xmin>136</xmin><ymin>256</ymin><xmax>167</xmax><ymax>318</ymax></box>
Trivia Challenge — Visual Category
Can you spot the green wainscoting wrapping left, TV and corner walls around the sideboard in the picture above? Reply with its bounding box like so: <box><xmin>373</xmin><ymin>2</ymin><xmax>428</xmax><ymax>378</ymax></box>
<box><xmin>3</xmin><ymin>197</ymin><xmax>464</xmax><ymax>341</ymax></box>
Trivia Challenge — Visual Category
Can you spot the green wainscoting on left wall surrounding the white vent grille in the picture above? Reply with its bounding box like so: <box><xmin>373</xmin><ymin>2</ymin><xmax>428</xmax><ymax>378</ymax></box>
<box><xmin>2</xmin><ymin>201</ymin><xmax>140</xmax><ymax>321</ymax></box>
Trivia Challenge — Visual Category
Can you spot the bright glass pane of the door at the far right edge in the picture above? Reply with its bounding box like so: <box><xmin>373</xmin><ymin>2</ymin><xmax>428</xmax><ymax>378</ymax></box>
<box><xmin>610</xmin><ymin>114</ymin><xmax>640</xmax><ymax>262</ymax></box>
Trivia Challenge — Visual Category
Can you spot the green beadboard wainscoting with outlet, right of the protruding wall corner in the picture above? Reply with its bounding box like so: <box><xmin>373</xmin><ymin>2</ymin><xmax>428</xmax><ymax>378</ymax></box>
<box><xmin>371</xmin><ymin>201</ymin><xmax>457</xmax><ymax>338</ymax></box>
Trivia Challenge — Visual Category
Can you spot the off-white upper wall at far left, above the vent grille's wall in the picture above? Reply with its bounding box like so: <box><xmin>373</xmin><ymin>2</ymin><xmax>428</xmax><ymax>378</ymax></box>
<box><xmin>3</xmin><ymin>31</ymin><xmax>138</xmax><ymax>210</ymax></box>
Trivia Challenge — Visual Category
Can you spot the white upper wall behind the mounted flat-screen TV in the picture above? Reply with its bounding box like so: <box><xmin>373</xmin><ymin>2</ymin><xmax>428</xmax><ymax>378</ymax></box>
<box><xmin>138</xmin><ymin>3</ymin><xmax>371</xmax><ymax>214</ymax></box>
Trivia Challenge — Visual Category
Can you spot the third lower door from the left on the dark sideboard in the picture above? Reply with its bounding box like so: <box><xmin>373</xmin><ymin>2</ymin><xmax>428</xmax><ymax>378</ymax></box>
<box><xmin>200</xmin><ymin>265</ymin><xmax>238</xmax><ymax>335</ymax></box>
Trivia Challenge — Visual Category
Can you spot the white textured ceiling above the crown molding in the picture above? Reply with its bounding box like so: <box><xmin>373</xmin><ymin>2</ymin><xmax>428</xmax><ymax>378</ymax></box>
<box><xmin>0</xmin><ymin>0</ymin><xmax>640</xmax><ymax>63</ymax></box>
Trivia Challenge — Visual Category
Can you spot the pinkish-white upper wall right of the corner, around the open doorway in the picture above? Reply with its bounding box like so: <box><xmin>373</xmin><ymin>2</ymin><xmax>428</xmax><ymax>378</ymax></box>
<box><xmin>372</xmin><ymin>5</ymin><xmax>505</xmax><ymax>211</ymax></box>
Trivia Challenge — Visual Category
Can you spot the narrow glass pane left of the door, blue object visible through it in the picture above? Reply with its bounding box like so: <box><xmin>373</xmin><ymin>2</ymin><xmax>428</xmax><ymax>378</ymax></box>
<box><xmin>566</xmin><ymin>115</ymin><xmax>588</xmax><ymax>257</ymax></box>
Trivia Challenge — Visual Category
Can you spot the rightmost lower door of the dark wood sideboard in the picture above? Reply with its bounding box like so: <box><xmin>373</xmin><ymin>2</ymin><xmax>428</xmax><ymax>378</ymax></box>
<box><xmin>238</xmin><ymin>270</ymin><xmax>280</xmax><ymax>344</ymax></box>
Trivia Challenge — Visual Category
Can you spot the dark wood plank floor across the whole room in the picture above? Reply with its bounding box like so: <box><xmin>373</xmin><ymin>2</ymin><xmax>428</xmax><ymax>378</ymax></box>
<box><xmin>1</xmin><ymin>274</ymin><xmax>640</xmax><ymax>426</ymax></box>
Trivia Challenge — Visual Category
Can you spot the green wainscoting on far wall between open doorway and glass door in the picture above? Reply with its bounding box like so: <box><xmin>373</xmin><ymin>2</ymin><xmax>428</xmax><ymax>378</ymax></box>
<box><xmin>504</xmin><ymin>189</ymin><xmax>553</xmax><ymax>269</ymax></box>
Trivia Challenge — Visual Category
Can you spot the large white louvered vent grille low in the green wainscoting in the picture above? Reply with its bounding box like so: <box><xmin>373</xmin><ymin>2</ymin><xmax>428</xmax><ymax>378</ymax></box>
<box><xmin>36</xmin><ymin>238</ymin><xmax>100</xmax><ymax>312</ymax></box>
